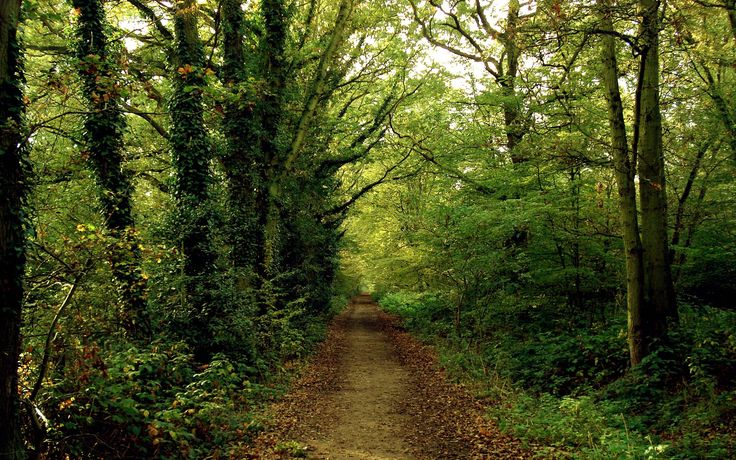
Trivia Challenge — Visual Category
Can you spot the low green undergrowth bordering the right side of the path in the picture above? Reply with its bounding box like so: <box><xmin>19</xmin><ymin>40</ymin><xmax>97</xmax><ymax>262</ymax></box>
<box><xmin>378</xmin><ymin>292</ymin><xmax>736</xmax><ymax>459</ymax></box>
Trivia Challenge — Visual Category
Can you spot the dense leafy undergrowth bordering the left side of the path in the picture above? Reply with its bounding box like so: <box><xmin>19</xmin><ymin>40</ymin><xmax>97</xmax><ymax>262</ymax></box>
<box><xmin>21</xmin><ymin>293</ymin><xmax>346</xmax><ymax>459</ymax></box>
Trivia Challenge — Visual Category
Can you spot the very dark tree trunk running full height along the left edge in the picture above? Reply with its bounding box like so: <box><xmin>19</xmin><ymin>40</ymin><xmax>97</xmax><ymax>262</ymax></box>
<box><xmin>0</xmin><ymin>0</ymin><xmax>26</xmax><ymax>460</ymax></box>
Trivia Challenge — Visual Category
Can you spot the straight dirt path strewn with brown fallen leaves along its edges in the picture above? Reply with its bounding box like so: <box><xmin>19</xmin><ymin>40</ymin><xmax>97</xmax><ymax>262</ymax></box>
<box><xmin>248</xmin><ymin>295</ymin><xmax>532</xmax><ymax>459</ymax></box>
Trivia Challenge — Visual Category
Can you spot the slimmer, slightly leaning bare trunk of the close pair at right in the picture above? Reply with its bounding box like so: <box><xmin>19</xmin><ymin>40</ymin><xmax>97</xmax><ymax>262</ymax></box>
<box><xmin>601</xmin><ymin>4</ymin><xmax>648</xmax><ymax>366</ymax></box>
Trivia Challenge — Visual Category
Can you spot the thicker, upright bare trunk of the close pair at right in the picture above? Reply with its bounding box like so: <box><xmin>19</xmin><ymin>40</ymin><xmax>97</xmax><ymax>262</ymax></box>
<box><xmin>637</xmin><ymin>0</ymin><xmax>677</xmax><ymax>340</ymax></box>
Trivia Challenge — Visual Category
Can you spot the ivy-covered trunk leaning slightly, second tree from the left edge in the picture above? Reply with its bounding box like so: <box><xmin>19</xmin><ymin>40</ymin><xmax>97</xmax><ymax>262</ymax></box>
<box><xmin>72</xmin><ymin>0</ymin><xmax>149</xmax><ymax>337</ymax></box>
